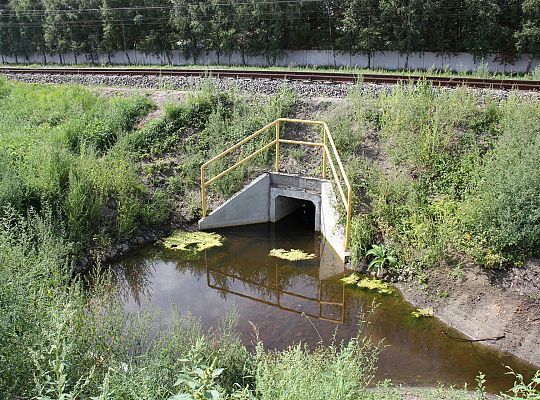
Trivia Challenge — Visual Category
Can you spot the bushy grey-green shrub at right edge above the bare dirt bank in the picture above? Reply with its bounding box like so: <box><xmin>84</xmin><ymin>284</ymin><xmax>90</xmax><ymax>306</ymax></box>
<box><xmin>465</xmin><ymin>99</ymin><xmax>540</xmax><ymax>266</ymax></box>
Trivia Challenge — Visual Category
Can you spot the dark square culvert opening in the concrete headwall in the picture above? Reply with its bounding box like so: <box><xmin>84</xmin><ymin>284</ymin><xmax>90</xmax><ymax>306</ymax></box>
<box><xmin>276</xmin><ymin>196</ymin><xmax>316</xmax><ymax>230</ymax></box>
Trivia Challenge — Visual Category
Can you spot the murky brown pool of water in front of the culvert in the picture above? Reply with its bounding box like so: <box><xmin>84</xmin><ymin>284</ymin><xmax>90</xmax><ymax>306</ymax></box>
<box><xmin>107</xmin><ymin>214</ymin><xmax>534</xmax><ymax>392</ymax></box>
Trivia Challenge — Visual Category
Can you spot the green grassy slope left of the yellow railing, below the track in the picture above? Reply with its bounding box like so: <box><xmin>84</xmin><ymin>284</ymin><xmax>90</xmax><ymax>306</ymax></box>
<box><xmin>0</xmin><ymin>78</ymin><xmax>294</xmax><ymax>250</ymax></box>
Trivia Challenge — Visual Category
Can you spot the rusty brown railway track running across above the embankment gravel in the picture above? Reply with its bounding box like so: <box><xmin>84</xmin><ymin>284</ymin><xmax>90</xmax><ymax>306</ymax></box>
<box><xmin>0</xmin><ymin>67</ymin><xmax>540</xmax><ymax>91</ymax></box>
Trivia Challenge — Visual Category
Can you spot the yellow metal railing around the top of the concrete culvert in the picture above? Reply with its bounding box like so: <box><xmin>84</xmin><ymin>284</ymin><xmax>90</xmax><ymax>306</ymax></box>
<box><xmin>201</xmin><ymin>118</ymin><xmax>352</xmax><ymax>250</ymax></box>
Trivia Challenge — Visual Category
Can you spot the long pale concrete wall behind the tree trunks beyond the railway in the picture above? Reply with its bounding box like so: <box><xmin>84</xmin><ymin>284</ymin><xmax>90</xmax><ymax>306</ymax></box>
<box><xmin>0</xmin><ymin>50</ymin><xmax>540</xmax><ymax>72</ymax></box>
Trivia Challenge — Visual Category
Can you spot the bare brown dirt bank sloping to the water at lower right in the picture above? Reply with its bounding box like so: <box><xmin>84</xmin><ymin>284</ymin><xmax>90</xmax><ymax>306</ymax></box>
<box><xmin>397</xmin><ymin>259</ymin><xmax>540</xmax><ymax>367</ymax></box>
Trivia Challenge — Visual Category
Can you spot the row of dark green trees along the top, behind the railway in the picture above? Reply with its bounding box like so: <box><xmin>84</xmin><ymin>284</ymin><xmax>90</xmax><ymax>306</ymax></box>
<box><xmin>0</xmin><ymin>0</ymin><xmax>540</xmax><ymax>68</ymax></box>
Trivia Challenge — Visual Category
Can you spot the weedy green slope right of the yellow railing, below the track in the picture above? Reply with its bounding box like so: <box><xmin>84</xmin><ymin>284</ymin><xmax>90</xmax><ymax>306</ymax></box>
<box><xmin>327</xmin><ymin>79</ymin><xmax>540</xmax><ymax>270</ymax></box>
